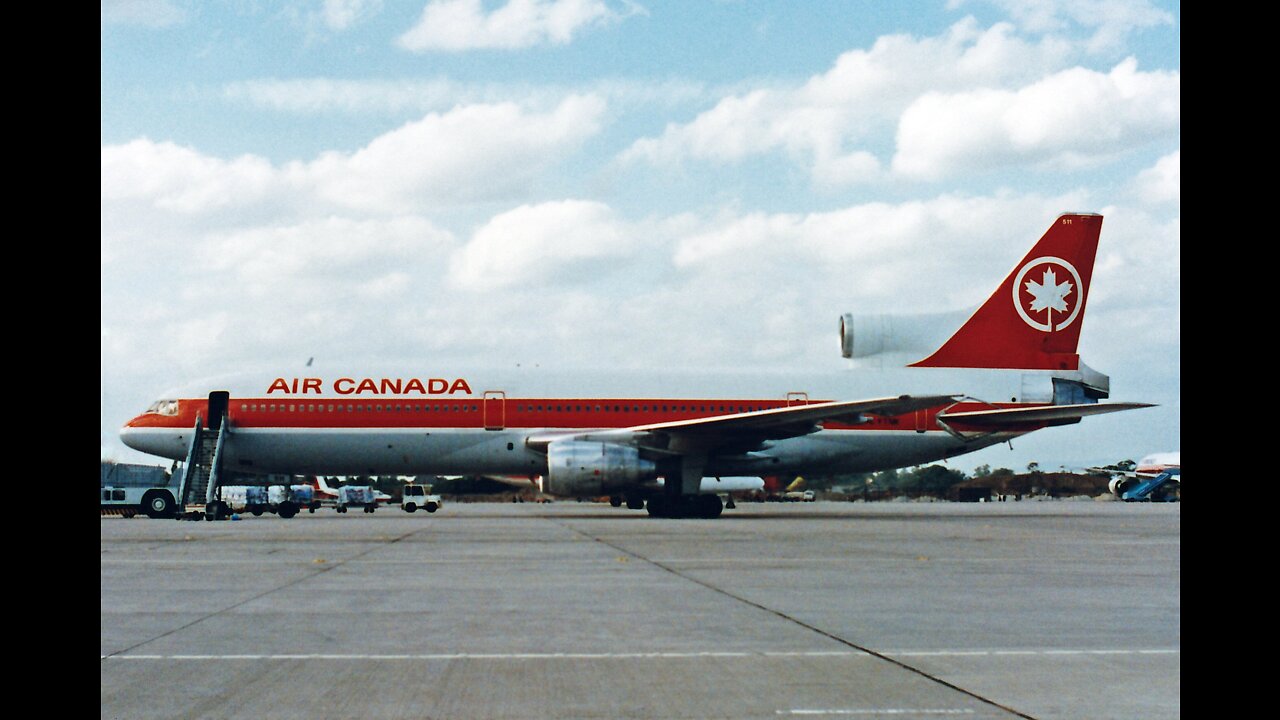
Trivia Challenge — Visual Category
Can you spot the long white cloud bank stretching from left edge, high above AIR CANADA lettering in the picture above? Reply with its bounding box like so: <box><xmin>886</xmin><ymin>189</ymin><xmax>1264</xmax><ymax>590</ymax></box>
<box><xmin>101</xmin><ymin>96</ymin><xmax>604</xmax><ymax>214</ymax></box>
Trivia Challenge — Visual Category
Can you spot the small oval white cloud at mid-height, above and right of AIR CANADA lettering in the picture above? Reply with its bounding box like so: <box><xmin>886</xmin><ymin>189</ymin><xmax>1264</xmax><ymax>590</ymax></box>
<box><xmin>449</xmin><ymin>200</ymin><xmax>634</xmax><ymax>290</ymax></box>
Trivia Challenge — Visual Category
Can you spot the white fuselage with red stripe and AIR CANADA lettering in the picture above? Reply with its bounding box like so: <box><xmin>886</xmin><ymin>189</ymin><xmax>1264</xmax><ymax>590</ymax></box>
<box><xmin>122</xmin><ymin>366</ymin><xmax>1064</xmax><ymax>477</ymax></box>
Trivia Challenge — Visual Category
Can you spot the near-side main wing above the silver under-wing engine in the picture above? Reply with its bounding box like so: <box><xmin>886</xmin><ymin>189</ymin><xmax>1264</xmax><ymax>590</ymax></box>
<box><xmin>526</xmin><ymin>395</ymin><xmax>960</xmax><ymax>452</ymax></box>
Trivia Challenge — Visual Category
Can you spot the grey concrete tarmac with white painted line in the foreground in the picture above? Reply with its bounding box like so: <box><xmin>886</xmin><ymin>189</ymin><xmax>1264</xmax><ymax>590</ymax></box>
<box><xmin>101</xmin><ymin>500</ymin><xmax>1181</xmax><ymax>720</ymax></box>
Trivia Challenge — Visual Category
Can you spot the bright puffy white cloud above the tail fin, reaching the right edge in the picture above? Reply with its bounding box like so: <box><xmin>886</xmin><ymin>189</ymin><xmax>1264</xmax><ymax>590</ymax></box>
<box><xmin>892</xmin><ymin>58</ymin><xmax>1180</xmax><ymax>181</ymax></box>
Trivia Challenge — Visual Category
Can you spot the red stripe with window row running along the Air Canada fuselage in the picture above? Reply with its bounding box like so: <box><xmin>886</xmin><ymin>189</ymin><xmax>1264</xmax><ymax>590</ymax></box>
<box><xmin>127</xmin><ymin>397</ymin><xmax>1028</xmax><ymax>430</ymax></box>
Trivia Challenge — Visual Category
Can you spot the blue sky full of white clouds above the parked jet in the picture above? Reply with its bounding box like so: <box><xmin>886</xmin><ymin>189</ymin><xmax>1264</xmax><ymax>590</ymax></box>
<box><xmin>101</xmin><ymin>0</ymin><xmax>1180</xmax><ymax>473</ymax></box>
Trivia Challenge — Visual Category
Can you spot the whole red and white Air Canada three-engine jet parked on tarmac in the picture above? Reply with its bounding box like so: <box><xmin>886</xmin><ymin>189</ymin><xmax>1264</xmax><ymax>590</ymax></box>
<box><xmin>120</xmin><ymin>213</ymin><xmax>1151</xmax><ymax>518</ymax></box>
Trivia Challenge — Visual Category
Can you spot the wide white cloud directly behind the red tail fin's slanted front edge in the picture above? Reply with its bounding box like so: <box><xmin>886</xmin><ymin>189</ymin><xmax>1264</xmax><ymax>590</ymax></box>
<box><xmin>673</xmin><ymin>193</ymin><xmax>1089</xmax><ymax>311</ymax></box>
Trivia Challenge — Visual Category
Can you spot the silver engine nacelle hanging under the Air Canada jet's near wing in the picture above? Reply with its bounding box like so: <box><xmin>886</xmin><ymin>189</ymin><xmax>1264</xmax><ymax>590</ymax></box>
<box><xmin>543</xmin><ymin>441</ymin><xmax>658</xmax><ymax>496</ymax></box>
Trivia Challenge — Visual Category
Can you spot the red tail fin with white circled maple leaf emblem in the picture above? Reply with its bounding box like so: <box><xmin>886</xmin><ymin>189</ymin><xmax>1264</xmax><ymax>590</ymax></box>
<box><xmin>913</xmin><ymin>213</ymin><xmax>1102</xmax><ymax>370</ymax></box>
